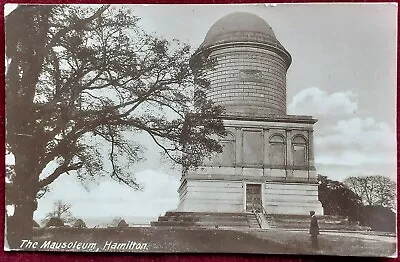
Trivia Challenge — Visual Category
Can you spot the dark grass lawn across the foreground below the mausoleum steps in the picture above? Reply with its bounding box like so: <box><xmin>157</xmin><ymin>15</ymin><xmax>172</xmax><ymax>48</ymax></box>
<box><xmin>22</xmin><ymin>227</ymin><xmax>396</xmax><ymax>256</ymax></box>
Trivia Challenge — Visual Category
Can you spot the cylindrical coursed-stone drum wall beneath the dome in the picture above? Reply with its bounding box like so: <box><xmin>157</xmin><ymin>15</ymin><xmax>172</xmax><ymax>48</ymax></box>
<box><xmin>206</xmin><ymin>46</ymin><xmax>287</xmax><ymax>116</ymax></box>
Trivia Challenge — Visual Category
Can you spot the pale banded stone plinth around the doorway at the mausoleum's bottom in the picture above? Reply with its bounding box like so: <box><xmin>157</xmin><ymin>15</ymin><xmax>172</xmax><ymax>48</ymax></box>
<box><xmin>176</xmin><ymin>177</ymin><xmax>323</xmax><ymax>215</ymax></box>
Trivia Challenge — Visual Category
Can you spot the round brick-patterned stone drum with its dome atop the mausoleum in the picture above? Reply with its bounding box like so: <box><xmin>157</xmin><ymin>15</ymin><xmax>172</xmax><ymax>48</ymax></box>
<box><xmin>194</xmin><ymin>12</ymin><xmax>292</xmax><ymax>117</ymax></box>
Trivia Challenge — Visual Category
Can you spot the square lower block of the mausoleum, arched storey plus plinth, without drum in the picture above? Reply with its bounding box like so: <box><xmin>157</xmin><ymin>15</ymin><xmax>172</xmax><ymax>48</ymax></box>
<box><xmin>178</xmin><ymin>116</ymin><xmax>323</xmax><ymax>215</ymax></box>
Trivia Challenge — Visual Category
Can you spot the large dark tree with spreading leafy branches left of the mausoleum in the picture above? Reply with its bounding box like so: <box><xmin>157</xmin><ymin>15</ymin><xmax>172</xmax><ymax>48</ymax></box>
<box><xmin>5</xmin><ymin>5</ymin><xmax>226</xmax><ymax>245</ymax></box>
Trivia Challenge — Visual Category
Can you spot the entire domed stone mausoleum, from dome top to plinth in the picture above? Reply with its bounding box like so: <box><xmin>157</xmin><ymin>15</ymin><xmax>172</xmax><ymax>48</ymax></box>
<box><xmin>176</xmin><ymin>12</ymin><xmax>323</xmax><ymax>215</ymax></box>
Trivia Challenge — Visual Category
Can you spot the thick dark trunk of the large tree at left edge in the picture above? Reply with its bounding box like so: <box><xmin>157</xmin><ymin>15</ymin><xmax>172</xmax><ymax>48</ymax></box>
<box><xmin>5</xmin><ymin>5</ymin><xmax>53</xmax><ymax>249</ymax></box>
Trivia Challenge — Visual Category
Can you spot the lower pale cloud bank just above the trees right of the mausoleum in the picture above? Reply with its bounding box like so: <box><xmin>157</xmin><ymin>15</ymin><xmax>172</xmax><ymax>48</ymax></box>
<box><xmin>315</xmin><ymin>117</ymin><xmax>396</xmax><ymax>179</ymax></box>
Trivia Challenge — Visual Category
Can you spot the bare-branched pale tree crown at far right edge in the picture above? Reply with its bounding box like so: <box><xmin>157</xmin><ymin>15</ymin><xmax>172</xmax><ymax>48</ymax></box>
<box><xmin>344</xmin><ymin>176</ymin><xmax>396</xmax><ymax>208</ymax></box>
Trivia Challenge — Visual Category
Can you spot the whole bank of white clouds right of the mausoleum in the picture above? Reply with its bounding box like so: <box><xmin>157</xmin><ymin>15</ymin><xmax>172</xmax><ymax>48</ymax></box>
<box><xmin>288</xmin><ymin>87</ymin><xmax>396</xmax><ymax>179</ymax></box>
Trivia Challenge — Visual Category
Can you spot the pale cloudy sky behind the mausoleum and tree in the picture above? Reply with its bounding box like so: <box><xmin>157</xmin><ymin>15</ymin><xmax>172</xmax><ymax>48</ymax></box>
<box><xmin>5</xmin><ymin>3</ymin><xmax>397</xmax><ymax>223</ymax></box>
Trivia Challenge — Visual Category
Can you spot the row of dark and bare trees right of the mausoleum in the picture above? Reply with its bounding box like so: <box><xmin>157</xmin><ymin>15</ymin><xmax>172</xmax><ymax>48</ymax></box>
<box><xmin>318</xmin><ymin>175</ymin><xmax>396</xmax><ymax>232</ymax></box>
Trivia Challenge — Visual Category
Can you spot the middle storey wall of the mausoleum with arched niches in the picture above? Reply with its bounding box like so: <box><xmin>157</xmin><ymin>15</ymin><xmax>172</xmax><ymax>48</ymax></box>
<box><xmin>203</xmin><ymin>120</ymin><xmax>316</xmax><ymax>182</ymax></box>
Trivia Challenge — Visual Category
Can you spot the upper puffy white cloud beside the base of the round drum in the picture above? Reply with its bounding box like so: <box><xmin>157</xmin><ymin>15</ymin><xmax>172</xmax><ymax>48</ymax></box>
<box><xmin>288</xmin><ymin>87</ymin><xmax>358</xmax><ymax>116</ymax></box>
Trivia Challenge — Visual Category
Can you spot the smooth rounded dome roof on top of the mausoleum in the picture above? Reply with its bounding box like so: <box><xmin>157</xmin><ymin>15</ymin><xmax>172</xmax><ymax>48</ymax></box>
<box><xmin>201</xmin><ymin>12</ymin><xmax>277</xmax><ymax>47</ymax></box>
